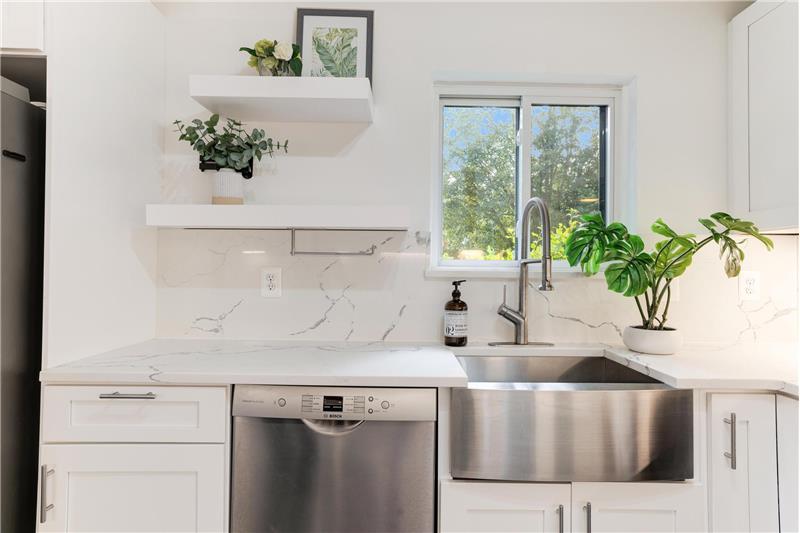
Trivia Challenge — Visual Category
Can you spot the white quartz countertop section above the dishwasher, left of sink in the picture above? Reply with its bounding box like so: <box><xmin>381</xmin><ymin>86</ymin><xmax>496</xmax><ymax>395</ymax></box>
<box><xmin>40</xmin><ymin>339</ymin><xmax>467</xmax><ymax>387</ymax></box>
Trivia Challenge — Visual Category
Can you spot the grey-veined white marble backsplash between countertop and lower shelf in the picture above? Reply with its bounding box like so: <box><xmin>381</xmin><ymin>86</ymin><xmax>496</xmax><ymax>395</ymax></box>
<box><xmin>157</xmin><ymin>230</ymin><xmax>798</xmax><ymax>344</ymax></box>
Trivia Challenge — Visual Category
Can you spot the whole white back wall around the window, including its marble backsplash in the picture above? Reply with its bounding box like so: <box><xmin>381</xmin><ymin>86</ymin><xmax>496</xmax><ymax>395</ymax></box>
<box><xmin>158</xmin><ymin>2</ymin><xmax>797</xmax><ymax>342</ymax></box>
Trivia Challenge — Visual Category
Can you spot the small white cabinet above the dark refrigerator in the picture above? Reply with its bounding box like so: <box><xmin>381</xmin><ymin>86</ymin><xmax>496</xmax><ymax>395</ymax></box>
<box><xmin>0</xmin><ymin>0</ymin><xmax>44</xmax><ymax>52</ymax></box>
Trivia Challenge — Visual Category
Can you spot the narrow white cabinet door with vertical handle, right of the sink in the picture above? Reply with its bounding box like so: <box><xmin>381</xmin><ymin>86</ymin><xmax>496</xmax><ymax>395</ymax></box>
<box><xmin>708</xmin><ymin>394</ymin><xmax>778</xmax><ymax>532</ymax></box>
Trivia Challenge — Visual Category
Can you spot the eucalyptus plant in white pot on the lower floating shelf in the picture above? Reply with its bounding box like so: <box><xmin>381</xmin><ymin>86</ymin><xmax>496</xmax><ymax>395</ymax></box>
<box><xmin>173</xmin><ymin>114</ymin><xmax>289</xmax><ymax>204</ymax></box>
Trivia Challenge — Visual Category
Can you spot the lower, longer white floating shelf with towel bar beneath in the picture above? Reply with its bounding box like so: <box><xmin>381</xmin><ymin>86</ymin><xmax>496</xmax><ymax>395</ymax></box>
<box><xmin>146</xmin><ymin>204</ymin><xmax>408</xmax><ymax>231</ymax></box>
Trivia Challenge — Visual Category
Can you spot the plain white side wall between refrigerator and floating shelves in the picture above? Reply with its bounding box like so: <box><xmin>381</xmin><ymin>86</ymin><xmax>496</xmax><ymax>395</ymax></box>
<box><xmin>44</xmin><ymin>2</ymin><xmax>164</xmax><ymax>366</ymax></box>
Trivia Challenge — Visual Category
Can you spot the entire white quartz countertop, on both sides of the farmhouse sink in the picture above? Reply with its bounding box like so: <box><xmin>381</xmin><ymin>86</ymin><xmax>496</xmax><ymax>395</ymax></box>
<box><xmin>36</xmin><ymin>339</ymin><xmax>798</xmax><ymax>397</ymax></box>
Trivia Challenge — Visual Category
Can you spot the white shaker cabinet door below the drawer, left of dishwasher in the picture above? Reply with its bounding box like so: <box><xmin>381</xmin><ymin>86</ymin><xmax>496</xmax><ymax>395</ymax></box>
<box><xmin>37</xmin><ymin>444</ymin><xmax>225</xmax><ymax>533</ymax></box>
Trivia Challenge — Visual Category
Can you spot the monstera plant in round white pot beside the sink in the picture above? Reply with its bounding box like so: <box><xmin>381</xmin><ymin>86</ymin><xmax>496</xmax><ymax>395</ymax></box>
<box><xmin>566</xmin><ymin>213</ymin><xmax>772</xmax><ymax>355</ymax></box>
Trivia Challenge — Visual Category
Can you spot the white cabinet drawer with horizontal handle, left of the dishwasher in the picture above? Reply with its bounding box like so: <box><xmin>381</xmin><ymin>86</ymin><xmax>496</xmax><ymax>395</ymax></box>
<box><xmin>42</xmin><ymin>385</ymin><xmax>227</xmax><ymax>443</ymax></box>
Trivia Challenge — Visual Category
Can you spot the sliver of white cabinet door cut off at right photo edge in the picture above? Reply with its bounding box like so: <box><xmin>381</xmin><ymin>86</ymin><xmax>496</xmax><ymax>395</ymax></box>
<box><xmin>776</xmin><ymin>396</ymin><xmax>800</xmax><ymax>533</ymax></box>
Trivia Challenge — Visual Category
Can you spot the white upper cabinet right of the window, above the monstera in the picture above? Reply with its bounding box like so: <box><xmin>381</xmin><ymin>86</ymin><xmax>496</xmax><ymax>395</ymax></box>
<box><xmin>728</xmin><ymin>0</ymin><xmax>798</xmax><ymax>231</ymax></box>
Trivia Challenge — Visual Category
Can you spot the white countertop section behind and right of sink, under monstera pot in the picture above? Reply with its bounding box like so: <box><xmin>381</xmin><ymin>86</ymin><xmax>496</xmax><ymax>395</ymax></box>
<box><xmin>453</xmin><ymin>343</ymin><xmax>798</xmax><ymax>397</ymax></box>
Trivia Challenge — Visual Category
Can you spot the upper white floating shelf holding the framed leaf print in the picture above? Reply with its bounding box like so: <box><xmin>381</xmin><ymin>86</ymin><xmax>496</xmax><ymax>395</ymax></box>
<box><xmin>189</xmin><ymin>75</ymin><xmax>372</xmax><ymax>122</ymax></box>
